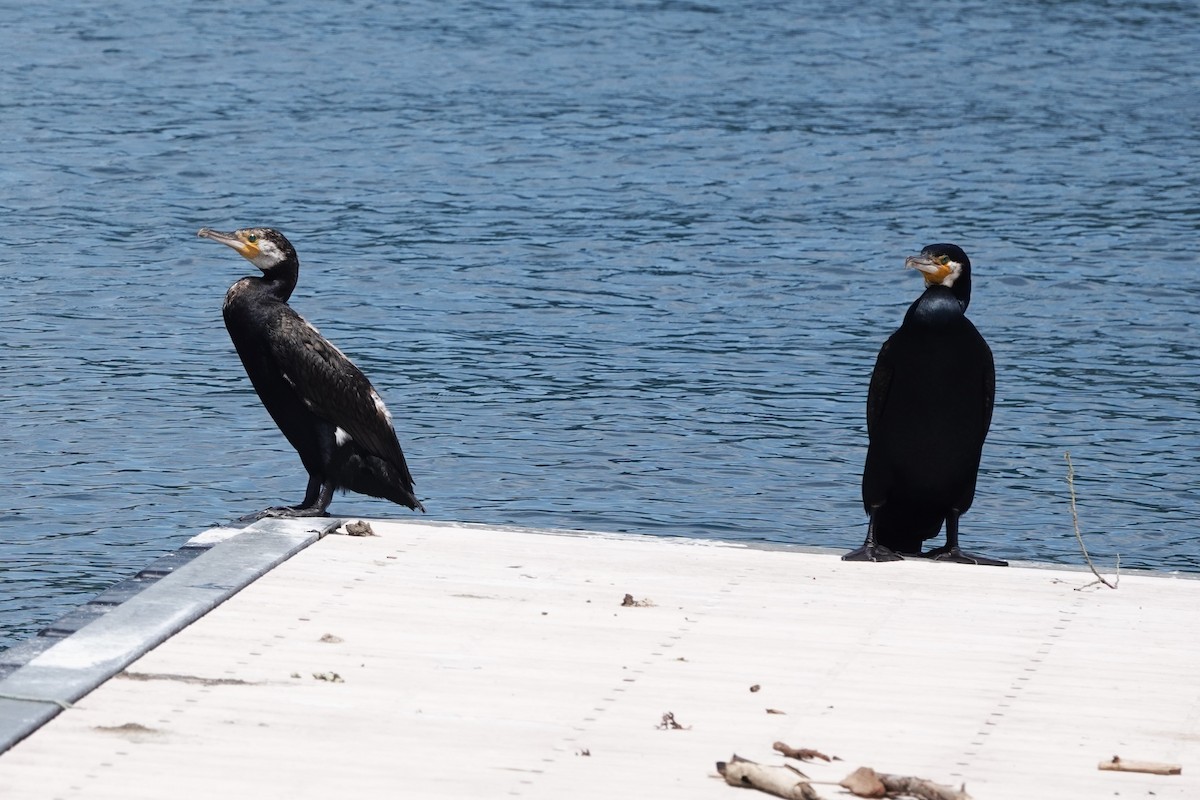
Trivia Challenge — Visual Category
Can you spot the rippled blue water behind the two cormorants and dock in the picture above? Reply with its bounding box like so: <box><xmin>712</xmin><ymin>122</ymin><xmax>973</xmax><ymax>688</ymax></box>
<box><xmin>0</xmin><ymin>0</ymin><xmax>1200</xmax><ymax>646</ymax></box>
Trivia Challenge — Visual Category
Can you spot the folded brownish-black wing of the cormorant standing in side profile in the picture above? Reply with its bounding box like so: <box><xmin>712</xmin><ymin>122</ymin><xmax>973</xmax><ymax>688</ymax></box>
<box><xmin>271</xmin><ymin>308</ymin><xmax>412</xmax><ymax>480</ymax></box>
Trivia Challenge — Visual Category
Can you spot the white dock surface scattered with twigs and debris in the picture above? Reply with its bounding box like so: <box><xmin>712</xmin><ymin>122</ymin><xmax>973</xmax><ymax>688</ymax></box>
<box><xmin>0</xmin><ymin>522</ymin><xmax>1200</xmax><ymax>800</ymax></box>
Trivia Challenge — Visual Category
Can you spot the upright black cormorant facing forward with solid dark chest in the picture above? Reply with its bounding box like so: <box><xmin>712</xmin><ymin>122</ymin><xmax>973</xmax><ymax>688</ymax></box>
<box><xmin>842</xmin><ymin>243</ymin><xmax>1007</xmax><ymax>566</ymax></box>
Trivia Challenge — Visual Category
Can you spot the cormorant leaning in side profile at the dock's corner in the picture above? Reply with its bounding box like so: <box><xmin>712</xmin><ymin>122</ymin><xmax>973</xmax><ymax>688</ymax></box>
<box><xmin>197</xmin><ymin>228</ymin><xmax>425</xmax><ymax>517</ymax></box>
